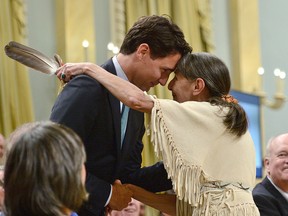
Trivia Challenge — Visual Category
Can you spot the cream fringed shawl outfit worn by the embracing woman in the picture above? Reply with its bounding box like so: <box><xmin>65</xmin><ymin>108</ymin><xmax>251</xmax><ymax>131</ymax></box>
<box><xmin>148</xmin><ymin>98</ymin><xmax>259</xmax><ymax>215</ymax></box>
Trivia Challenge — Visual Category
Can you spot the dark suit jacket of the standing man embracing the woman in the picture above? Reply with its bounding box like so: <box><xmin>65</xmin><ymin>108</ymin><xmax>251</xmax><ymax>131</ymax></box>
<box><xmin>50</xmin><ymin>59</ymin><xmax>172</xmax><ymax>216</ymax></box>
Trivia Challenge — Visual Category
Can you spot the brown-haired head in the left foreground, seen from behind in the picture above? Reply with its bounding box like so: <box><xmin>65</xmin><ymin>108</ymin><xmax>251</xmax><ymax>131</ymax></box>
<box><xmin>4</xmin><ymin>122</ymin><xmax>87</xmax><ymax>216</ymax></box>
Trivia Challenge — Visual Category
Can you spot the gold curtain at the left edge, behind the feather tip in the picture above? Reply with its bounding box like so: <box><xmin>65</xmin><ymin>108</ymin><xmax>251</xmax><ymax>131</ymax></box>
<box><xmin>0</xmin><ymin>0</ymin><xmax>34</xmax><ymax>136</ymax></box>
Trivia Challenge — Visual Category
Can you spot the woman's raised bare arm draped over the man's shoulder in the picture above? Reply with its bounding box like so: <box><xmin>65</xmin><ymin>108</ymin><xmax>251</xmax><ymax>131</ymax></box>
<box><xmin>56</xmin><ymin>63</ymin><xmax>154</xmax><ymax>113</ymax></box>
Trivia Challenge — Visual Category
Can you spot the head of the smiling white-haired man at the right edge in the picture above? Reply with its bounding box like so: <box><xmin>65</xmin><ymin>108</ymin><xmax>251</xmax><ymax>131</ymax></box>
<box><xmin>265</xmin><ymin>134</ymin><xmax>288</xmax><ymax>192</ymax></box>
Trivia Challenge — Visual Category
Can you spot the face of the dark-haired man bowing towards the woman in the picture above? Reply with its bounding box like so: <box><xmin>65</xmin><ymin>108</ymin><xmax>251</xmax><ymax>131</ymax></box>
<box><xmin>131</xmin><ymin>53</ymin><xmax>181</xmax><ymax>91</ymax></box>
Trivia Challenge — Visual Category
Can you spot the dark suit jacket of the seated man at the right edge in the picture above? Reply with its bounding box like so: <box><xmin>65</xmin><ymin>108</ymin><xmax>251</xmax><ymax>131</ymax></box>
<box><xmin>253</xmin><ymin>177</ymin><xmax>288</xmax><ymax>216</ymax></box>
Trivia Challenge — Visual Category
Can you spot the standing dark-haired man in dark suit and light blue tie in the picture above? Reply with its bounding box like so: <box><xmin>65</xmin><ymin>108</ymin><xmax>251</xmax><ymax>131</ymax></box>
<box><xmin>50</xmin><ymin>16</ymin><xmax>192</xmax><ymax>216</ymax></box>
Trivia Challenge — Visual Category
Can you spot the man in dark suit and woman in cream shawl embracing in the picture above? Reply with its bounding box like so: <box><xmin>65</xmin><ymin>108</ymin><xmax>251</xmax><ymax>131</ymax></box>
<box><xmin>1</xmin><ymin>15</ymin><xmax>259</xmax><ymax>216</ymax></box>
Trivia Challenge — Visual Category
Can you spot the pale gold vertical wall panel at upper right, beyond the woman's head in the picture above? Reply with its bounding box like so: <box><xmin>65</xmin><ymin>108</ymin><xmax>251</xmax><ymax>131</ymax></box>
<box><xmin>229</xmin><ymin>0</ymin><xmax>261</xmax><ymax>92</ymax></box>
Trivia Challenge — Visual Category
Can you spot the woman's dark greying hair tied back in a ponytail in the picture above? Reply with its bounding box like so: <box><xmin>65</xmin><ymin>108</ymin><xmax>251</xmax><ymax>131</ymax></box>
<box><xmin>176</xmin><ymin>53</ymin><xmax>248</xmax><ymax>136</ymax></box>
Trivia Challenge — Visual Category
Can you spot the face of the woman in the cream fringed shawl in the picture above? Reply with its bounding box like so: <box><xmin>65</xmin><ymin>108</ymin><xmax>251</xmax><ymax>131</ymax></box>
<box><xmin>168</xmin><ymin>73</ymin><xmax>195</xmax><ymax>103</ymax></box>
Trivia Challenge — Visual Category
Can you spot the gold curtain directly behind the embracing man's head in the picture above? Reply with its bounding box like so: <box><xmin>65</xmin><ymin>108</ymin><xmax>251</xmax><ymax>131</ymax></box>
<box><xmin>125</xmin><ymin>0</ymin><xmax>214</xmax><ymax>166</ymax></box>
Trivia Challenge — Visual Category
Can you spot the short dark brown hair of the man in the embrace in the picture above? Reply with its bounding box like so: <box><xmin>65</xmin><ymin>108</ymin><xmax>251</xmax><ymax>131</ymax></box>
<box><xmin>120</xmin><ymin>15</ymin><xmax>192</xmax><ymax>59</ymax></box>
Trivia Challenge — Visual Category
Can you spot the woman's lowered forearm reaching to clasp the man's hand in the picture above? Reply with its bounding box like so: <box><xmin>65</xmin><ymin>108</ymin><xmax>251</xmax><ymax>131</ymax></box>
<box><xmin>127</xmin><ymin>184</ymin><xmax>176</xmax><ymax>215</ymax></box>
